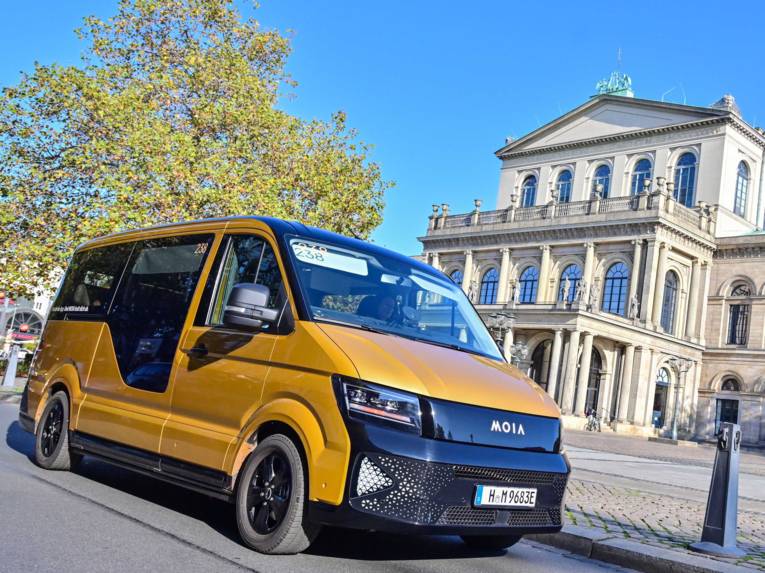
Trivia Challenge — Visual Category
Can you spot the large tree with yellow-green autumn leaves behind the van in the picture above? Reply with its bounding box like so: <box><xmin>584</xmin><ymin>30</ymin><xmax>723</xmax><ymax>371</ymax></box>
<box><xmin>0</xmin><ymin>0</ymin><xmax>390</xmax><ymax>294</ymax></box>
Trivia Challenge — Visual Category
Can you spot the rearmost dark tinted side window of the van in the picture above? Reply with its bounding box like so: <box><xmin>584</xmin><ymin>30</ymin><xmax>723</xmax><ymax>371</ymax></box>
<box><xmin>50</xmin><ymin>243</ymin><xmax>133</xmax><ymax>320</ymax></box>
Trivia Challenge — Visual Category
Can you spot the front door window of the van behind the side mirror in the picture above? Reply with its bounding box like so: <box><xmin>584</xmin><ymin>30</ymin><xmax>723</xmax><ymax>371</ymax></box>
<box><xmin>200</xmin><ymin>235</ymin><xmax>287</xmax><ymax>326</ymax></box>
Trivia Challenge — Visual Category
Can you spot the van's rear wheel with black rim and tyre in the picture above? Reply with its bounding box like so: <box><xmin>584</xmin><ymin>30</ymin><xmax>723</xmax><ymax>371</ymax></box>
<box><xmin>35</xmin><ymin>391</ymin><xmax>77</xmax><ymax>470</ymax></box>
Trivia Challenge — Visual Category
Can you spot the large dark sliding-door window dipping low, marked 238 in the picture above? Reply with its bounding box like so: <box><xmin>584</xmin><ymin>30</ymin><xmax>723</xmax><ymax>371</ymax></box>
<box><xmin>107</xmin><ymin>235</ymin><xmax>213</xmax><ymax>392</ymax></box>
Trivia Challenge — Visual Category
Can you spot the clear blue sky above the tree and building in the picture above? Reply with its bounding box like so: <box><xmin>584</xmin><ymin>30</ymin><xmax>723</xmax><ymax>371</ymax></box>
<box><xmin>0</xmin><ymin>0</ymin><xmax>765</xmax><ymax>254</ymax></box>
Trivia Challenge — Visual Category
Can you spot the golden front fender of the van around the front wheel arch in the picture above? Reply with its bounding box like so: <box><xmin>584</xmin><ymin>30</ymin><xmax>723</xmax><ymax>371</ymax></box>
<box><xmin>227</xmin><ymin>321</ymin><xmax>357</xmax><ymax>505</ymax></box>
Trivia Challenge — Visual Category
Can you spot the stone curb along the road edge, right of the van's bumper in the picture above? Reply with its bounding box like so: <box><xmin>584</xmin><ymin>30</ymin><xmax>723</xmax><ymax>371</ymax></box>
<box><xmin>524</xmin><ymin>525</ymin><xmax>751</xmax><ymax>573</ymax></box>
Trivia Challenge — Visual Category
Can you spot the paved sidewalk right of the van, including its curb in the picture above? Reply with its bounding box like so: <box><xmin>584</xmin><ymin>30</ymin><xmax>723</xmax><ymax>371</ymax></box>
<box><xmin>533</xmin><ymin>432</ymin><xmax>765</xmax><ymax>572</ymax></box>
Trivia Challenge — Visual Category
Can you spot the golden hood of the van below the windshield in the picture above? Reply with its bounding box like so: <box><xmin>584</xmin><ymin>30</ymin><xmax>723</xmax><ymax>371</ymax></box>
<box><xmin>317</xmin><ymin>323</ymin><xmax>560</xmax><ymax>418</ymax></box>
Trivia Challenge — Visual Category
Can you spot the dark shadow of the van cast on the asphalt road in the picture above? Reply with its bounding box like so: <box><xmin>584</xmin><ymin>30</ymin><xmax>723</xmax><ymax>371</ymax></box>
<box><xmin>5</xmin><ymin>422</ymin><xmax>505</xmax><ymax>561</ymax></box>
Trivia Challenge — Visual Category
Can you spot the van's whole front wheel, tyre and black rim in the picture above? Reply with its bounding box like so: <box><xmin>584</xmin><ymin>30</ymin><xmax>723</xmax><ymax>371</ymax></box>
<box><xmin>236</xmin><ymin>434</ymin><xmax>320</xmax><ymax>554</ymax></box>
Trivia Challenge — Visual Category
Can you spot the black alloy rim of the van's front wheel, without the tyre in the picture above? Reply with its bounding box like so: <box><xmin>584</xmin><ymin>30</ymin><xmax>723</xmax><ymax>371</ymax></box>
<box><xmin>247</xmin><ymin>451</ymin><xmax>292</xmax><ymax>535</ymax></box>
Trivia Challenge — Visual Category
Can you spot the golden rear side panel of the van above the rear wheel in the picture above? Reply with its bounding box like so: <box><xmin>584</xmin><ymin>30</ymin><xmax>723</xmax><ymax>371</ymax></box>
<box><xmin>27</xmin><ymin>320</ymin><xmax>104</xmax><ymax>429</ymax></box>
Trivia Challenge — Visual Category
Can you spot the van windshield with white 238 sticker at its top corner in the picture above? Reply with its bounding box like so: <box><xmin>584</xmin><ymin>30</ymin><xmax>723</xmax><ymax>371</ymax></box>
<box><xmin>287</xmin><ymin>236</ymin><xmax>503</xmax><ymax>360</ymax></box>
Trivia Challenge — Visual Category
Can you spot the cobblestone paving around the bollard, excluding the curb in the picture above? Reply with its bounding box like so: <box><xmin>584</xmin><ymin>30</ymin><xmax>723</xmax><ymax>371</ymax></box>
<box><xmin>566</xmin><ymin>426</ymin><xmax>765</xmax><ymax>571</ymax></box>
